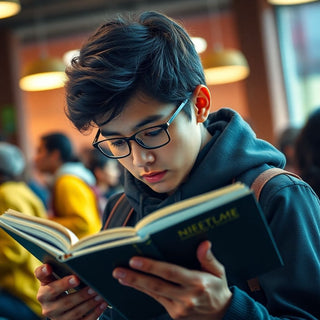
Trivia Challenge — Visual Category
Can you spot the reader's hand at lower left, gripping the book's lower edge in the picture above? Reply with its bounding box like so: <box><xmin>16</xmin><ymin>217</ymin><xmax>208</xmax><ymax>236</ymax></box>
<box><xmin>35</xmin><ymin>264</ymin><xmax>108</xmax><ymax>320</ymax></box>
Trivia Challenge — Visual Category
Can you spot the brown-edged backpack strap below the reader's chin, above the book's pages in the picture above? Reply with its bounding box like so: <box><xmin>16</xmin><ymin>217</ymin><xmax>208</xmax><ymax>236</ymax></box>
<box><xmin>103</xmin><ymin>193</ymin><xmax>134</xmax><ymax>230</ymax></box>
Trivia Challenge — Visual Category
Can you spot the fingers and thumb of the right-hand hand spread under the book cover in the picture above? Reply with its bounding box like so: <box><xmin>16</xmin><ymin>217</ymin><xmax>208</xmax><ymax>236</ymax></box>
<box><xmin>113</xmin><ymin>241</ymin><xmax>227</xmax><ymax>300</ymax></box>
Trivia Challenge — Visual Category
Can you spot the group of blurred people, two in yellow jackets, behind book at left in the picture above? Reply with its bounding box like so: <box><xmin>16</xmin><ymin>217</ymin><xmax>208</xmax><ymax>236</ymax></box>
<box><xmin>0</xmin><ymin>132</ymin><xmax>122</xmax><ymax>320</ymax></box>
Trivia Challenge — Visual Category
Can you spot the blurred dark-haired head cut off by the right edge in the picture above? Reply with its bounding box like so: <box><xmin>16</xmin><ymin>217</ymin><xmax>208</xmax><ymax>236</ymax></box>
<box><xmin>295</xmin><ymin>108</ymin><xmax>320</xmax><ymax>196</ymax></box>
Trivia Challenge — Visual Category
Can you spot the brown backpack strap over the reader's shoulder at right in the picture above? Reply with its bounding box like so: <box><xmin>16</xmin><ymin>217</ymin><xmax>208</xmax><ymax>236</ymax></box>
<box><xmin>247</xmin><ymin>168</ymin><xmax>301</xmax><ymax>292</ymax></box>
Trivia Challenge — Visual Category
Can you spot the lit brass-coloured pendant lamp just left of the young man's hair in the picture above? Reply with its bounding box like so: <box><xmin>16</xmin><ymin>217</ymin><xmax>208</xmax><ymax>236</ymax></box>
<box><xmin>19</xmin><ymin>58</ymin><xmax>66</xmax><ymax>91</ymax></box>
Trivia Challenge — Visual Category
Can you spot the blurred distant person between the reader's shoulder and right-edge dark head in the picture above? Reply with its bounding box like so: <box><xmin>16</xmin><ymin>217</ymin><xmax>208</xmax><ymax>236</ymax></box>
<box><xmin>278</xmin><ymin>126</ymin><xmax>300</xmax><ymax>173</ymax></box>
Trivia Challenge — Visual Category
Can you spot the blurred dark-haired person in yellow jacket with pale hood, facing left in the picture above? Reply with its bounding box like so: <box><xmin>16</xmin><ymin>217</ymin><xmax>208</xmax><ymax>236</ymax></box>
<box><xmin>35</xmin><ymin>132</ymin><xmax>101</xmax><ymax>238</ymax></box>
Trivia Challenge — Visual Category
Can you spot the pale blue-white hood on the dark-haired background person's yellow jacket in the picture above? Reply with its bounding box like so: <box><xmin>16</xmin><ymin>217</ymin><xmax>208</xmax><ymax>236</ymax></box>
<box><xmin>54</xmin><ymin>162</ymin><xmax>96</xmax><ymax>187</ymax></box>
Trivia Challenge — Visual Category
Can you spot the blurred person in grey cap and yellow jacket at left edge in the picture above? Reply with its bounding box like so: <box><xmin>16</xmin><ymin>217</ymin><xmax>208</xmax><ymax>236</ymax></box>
<box><xmin>0</xmin><ymin>142</ymin><xmax>46</xmax><ymax>320</ymax></box>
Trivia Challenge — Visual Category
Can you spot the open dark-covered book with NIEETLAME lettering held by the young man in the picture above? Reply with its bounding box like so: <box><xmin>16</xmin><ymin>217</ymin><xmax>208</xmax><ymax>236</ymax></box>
<box><xmin>0</xmin><ymin>183</ymin><xmax>282</xmax><ymax>319</ymax></box>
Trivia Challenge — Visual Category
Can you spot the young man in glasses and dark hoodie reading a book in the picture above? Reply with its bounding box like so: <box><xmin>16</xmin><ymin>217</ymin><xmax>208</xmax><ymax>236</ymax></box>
<box><xmin>36</xmin><ymin>12</ymin><xmax>320</xmax><ymax>320</ymax></box>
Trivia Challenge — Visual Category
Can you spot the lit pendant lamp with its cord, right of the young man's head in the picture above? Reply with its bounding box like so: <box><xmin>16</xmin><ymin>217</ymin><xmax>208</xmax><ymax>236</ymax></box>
<box><xmin>201</xmin><ymin>0</ymin><xmax>250</xmax><ymax>85</ymax></box>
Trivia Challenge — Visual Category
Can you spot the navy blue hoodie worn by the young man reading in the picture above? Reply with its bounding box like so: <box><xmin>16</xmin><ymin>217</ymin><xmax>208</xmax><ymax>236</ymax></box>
<box><xmin>100</xmin><ymin>109</ymin><xmax>320</xmax><ymax>320</ymax></box>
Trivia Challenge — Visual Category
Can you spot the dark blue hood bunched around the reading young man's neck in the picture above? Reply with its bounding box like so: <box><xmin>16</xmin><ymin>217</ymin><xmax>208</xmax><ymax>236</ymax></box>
<box><xmin>124</xmin><ymin>109</ymin><xmax>285</xmax><ymax>219</ymax></box>
